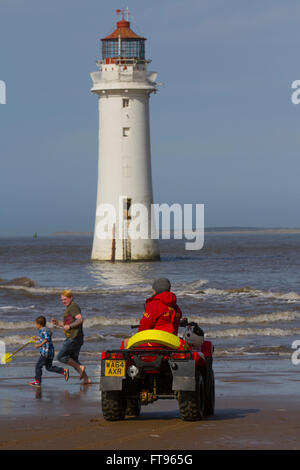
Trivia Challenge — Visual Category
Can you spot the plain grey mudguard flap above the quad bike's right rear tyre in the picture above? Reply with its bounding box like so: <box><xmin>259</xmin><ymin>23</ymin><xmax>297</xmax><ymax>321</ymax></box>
<box><xmin>171</xmin><ymin>361</ymin><xmax>196</xmax><ymax>392</ymax></box>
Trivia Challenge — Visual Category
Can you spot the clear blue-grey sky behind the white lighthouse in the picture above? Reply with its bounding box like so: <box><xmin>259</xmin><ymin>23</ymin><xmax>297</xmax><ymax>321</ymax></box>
<box><xmin>0</xmin><ymin>0</ymin><xmax>300</xmax><ymax>236</ymax></box>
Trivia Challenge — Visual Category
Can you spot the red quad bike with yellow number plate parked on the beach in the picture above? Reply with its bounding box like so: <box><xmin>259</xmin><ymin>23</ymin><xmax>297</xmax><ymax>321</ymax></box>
<box><xmin>100</xmin><ymin>324</ymin><xmax>215</xmax><ymax>421</ymax></box>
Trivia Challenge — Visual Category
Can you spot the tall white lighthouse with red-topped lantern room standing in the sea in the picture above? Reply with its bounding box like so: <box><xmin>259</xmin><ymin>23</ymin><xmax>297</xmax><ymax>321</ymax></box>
<box><xmin>91</xmin><ymin>10</ymin><xmax>159</xmax><ymax>261</ymax></box>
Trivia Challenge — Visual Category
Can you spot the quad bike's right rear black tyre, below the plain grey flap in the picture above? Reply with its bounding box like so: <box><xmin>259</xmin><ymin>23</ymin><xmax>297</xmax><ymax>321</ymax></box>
<box><xmin>178</xmin><ymin>375</ymin><xmax>205</xmax><ymax>421</ymax></box>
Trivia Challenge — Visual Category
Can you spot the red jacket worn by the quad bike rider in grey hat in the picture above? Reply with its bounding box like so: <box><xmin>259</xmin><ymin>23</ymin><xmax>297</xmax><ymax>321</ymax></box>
<box><xmin>139</xmin><ymin>291</ymin><xmax>182</xmax><ymax>335</ymax></box>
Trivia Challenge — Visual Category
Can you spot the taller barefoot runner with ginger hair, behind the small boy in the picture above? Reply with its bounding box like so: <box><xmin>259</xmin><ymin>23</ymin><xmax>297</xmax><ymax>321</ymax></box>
<box><xmin>52</xmin><ymin>290</ymin><xmax>91</xmax><ymax>385</ymax></box>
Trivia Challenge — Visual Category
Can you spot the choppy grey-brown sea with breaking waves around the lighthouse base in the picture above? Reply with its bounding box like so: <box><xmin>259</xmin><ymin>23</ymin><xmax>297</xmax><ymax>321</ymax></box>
<box><xmin>0</xmin><ymin>233</ymin><xmax>300</xmax><ymax>370</ymax></box>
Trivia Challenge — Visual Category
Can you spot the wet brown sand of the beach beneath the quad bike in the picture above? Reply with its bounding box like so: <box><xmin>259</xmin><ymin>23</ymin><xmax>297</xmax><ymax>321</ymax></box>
<box><xmin>0</xmin><ymin>360</ymin><xmax>300</xmax><ymax>450</ymax></box>
